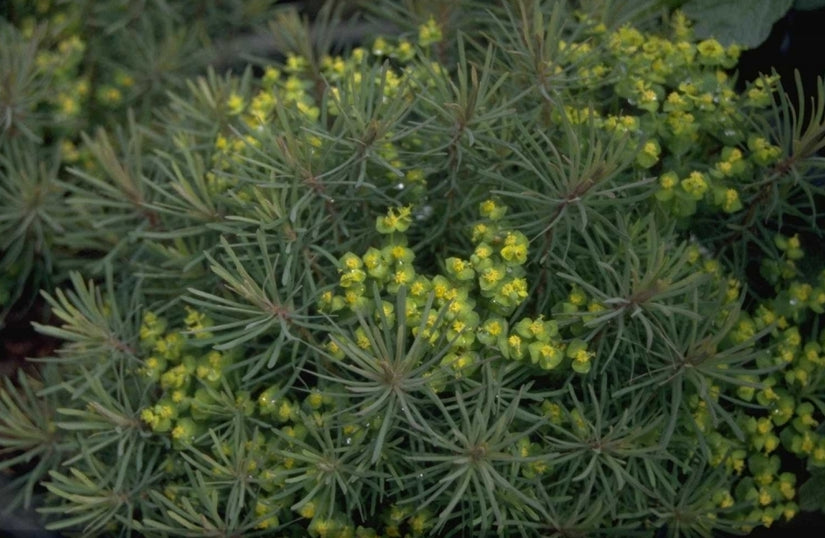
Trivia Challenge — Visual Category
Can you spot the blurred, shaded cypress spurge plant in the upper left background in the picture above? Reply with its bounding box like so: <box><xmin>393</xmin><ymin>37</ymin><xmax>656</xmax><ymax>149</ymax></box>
<box><xmin>0</xmin><ymin>0</ymin><xmax>286</xmax><ymax>322</ymax></box>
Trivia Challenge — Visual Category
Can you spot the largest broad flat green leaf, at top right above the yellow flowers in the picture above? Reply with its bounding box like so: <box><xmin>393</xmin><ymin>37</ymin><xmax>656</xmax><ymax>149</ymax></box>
<box><xmin>682</xmin><ymin>0</ymin><xmax>794</xmax><ymax>48</ymax></box>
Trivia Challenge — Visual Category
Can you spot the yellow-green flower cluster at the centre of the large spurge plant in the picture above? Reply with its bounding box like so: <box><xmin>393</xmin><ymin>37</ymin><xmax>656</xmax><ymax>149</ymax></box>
<box><xmin>320</xmin><ymin>200</ymin><xmax>592</xmax><ymax>380</ymax></box>
